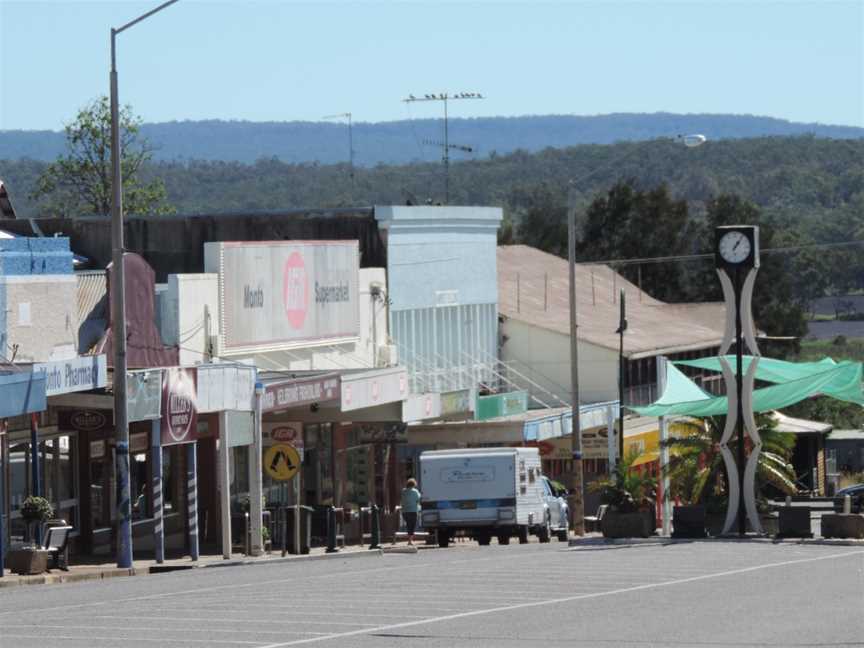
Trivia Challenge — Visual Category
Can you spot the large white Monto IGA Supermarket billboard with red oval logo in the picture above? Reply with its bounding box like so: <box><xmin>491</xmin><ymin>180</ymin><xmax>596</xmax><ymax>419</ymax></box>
<box><xmin>204</xmin><ymin>241</ymin><xmax>360</xmax><ymax>353</ymax></box>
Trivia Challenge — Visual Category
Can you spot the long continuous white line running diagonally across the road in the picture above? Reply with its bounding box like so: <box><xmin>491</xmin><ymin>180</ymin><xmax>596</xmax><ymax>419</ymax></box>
<box><xmin>253</xmin><ymin>551</ymin><xmax>864</xmax><ymax>648</ymax></box>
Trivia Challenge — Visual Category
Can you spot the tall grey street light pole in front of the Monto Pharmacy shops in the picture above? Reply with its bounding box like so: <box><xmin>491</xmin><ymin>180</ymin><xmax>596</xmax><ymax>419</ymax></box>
<box><xmin>111</xmin><ymin>0</ymin><xmax>177</xmax><ymax>569</ymax></box>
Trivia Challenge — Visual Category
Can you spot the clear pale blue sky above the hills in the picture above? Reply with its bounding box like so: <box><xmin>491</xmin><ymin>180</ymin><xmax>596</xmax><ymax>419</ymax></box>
<box><xmin>0</xmin><ymin>0</ymin><xmax>864</xmax><ymax>130</ymax></box>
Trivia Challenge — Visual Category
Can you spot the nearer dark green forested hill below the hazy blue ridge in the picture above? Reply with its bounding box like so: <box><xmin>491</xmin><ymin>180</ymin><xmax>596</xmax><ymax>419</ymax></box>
<box><xmin>0</xmin><ymin>136</ymin><xmax>864</xmax><ymax>229</ymax></box>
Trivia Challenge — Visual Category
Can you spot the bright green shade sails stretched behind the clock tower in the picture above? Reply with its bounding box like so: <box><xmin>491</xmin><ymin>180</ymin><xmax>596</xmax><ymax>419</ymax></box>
<box><xmin>628</xmin><ymin>356</ymin><xmax>864</xmax><ymax>417</ymax></box>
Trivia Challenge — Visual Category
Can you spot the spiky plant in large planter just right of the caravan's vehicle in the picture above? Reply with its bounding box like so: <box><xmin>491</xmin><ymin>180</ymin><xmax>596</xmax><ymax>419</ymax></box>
<box><xmin>589</xmin><ymin>451</ymin><xmax>657</xmax><ymax>538</ymax></box>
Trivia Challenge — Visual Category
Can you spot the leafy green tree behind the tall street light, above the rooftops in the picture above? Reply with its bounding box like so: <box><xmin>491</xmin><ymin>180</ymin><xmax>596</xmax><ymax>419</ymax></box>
<box><xmin>31</xmin><ymin>97</ymin><xmax>174</xmax><ymax>217</ymax></box>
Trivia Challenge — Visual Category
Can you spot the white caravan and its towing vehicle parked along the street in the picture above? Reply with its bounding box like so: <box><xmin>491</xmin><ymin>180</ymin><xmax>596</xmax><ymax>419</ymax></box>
<box><xmin>420</xmin><ymin>448</ymin><xmax>569</xmax><ymax>547</ymax></box>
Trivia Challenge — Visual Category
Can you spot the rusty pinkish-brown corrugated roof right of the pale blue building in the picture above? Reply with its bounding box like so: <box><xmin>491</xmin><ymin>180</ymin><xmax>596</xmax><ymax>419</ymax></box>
<box><xmin>498</xmin><ymin>245</ymin><xmax>725</xmax><ymax>359</ymax></box>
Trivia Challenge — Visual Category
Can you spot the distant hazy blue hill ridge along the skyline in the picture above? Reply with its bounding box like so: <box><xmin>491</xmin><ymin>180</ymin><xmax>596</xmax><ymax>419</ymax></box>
<box><xmin>0</xmin><ymin>113</ymin><xmax>864</xmax><ymax>166</ymax></box>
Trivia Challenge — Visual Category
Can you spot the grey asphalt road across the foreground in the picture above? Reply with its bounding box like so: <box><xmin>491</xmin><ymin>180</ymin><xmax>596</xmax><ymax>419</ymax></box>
<box><xmin>0</xmin><ymin>541</ymin><xmax>864</xmax><ymax>648</ymax></box>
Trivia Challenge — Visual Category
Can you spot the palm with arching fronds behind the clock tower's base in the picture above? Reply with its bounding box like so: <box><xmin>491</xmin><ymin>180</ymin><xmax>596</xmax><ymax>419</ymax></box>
<box><xmin>663</xmin><ymin>414</ymin><xmax>798</xmax><ymax>511</ymax></box>
